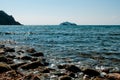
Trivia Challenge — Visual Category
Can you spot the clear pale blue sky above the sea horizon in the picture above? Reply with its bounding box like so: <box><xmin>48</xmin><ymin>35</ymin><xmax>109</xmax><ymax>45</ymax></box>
<box><xmin>0</xmin><ymin>0</ymin><xmax>120</xmax><ymax>25</ymax></box>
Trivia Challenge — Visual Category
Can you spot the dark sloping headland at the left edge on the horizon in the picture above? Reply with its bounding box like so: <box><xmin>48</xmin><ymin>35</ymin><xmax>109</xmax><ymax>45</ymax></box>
<box><xmin>0</xmin><ymin>10</ymin><xmax>21</xmax><ymax>25</ymax></box>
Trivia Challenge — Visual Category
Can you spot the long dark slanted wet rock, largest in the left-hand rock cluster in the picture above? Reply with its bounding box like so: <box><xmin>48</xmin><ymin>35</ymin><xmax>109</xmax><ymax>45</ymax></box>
<box><xmin>20</xmin><ymin>61</ymin><xmax>44</xmax><ymax>70</ymax></box>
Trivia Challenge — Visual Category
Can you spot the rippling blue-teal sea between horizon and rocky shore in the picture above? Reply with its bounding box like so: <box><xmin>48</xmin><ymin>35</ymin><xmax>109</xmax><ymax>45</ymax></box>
<box><xmin>0</xmin><ymin>25</ymin><xmax>120</xmax><ymax>70</ymax></box>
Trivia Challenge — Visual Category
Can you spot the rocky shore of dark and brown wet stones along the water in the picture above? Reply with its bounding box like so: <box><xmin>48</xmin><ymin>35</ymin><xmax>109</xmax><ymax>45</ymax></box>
<box><xmin>0</xmin><ymin>45</ymin><xmax>120</xmax><ymax>80</ymax></box>
